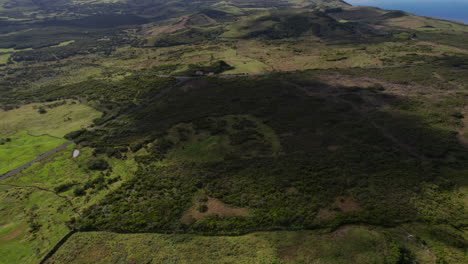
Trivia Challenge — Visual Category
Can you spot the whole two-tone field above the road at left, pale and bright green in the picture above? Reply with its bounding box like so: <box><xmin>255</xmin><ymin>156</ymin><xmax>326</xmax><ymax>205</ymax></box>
<box><xmin>0</xmin><ymin>100</ymin><xmax>101</xmax><ymax>175</ymax></box>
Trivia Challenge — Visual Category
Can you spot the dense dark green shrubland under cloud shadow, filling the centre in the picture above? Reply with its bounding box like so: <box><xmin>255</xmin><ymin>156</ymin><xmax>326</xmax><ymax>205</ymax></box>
<box><xmin>71</xmin><ymin>72</ymin><xmax>467</xmax><ymax>237</ymax></box>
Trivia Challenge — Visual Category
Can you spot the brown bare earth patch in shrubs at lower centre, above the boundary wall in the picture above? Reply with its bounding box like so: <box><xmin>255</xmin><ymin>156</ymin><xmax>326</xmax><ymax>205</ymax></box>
<box><xmin>181</xmin><ymin>197</ymin><xmax>249</xmax><ymax>224</ymax></box>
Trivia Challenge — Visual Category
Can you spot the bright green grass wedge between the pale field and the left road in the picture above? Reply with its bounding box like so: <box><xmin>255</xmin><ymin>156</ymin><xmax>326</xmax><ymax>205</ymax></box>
<box><xmin>0</xmin><ymin>131</ymin><xmax>66</xmax><ymax>175</ymax></box>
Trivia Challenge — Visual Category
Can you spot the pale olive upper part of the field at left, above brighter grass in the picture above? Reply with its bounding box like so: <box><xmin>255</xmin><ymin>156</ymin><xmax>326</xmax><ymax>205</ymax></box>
<box><xmin>0</xmin><ymin>100</ymin><xmax>101</xmax><ymax>137</ymax></box>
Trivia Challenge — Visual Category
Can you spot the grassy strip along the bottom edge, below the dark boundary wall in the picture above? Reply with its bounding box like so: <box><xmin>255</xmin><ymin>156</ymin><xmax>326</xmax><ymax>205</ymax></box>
<box><xmin>46</xmin><ymin>226</ymin><xmax>434</xmax><ymax>264</ymax></box>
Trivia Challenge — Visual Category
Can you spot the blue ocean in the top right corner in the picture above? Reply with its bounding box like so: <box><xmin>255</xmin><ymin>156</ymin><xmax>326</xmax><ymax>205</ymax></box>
<box><xmin>345</xmin><ymin>0</ymin><xmax>468</xmax><ymax>24</ymax></box>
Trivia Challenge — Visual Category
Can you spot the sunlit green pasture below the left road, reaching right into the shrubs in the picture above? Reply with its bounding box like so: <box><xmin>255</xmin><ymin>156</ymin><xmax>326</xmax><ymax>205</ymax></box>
<box><xmin>0</xmin><ymin>145</ymin><xmax>135</xmax><ymax>264</ymax></box>
